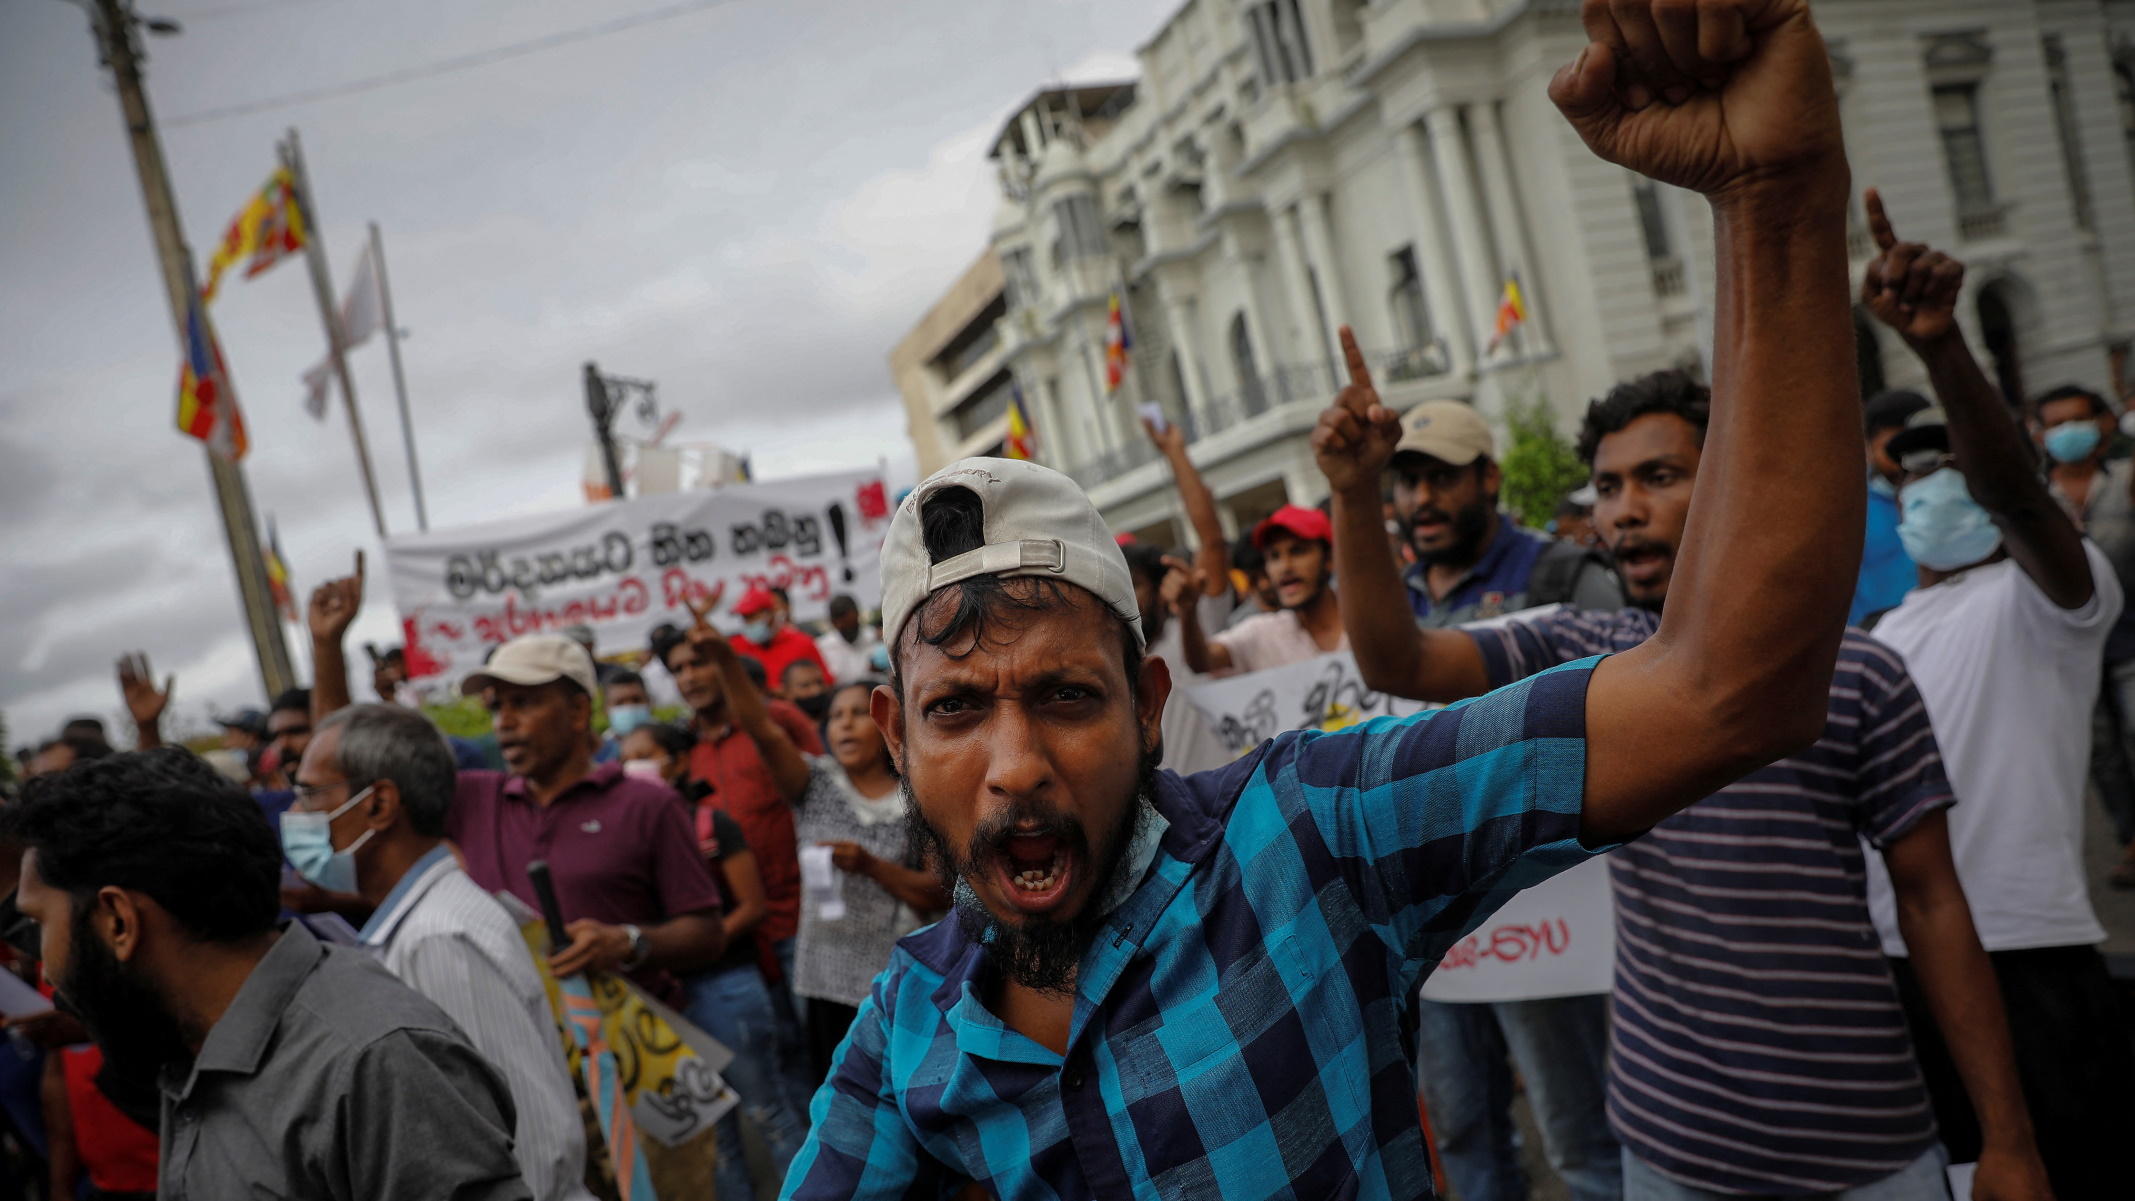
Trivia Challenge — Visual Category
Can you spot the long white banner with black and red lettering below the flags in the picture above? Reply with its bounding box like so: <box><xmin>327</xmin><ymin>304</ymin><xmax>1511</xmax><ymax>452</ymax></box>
<box><xmin>386</xmin><ymin>471</ymin><xmax>890</xmax><ymax>685</ymax></box>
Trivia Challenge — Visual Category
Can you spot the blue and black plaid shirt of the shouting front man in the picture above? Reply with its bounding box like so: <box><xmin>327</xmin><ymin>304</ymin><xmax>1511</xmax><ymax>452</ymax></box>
<box><xmin>784</xmin><ymin>659</ymin><xmax>1597</xmax><ymax>1201</ymax></box>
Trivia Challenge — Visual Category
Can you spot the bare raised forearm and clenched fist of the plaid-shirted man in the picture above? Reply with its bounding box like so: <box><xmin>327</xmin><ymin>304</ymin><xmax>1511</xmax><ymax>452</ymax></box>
<box><xmin>1550</xmin><ymin>0</ymin><xmax>1866</xmax><ymax>843</ymax></box>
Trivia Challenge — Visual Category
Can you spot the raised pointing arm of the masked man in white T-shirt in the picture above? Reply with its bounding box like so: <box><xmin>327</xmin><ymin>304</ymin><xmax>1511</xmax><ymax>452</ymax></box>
<box><xmin>1862</xmin><ymin>198</ymin><xmax>2094</xmax><ymax>608</ymax></box>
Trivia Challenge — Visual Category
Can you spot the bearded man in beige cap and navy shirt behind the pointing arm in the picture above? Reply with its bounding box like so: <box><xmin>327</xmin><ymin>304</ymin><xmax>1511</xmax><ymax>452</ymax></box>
<box><xmin>1390</xmin><ymin>401</ymin><xmax>1623</xmax><ymax>627</ymax></box>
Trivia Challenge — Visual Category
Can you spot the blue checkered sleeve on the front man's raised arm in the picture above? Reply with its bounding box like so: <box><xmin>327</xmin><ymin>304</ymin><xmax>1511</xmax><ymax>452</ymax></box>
<box><xmin>1232</xmin><ymin>659</ymin><xmax>1597</xmax><ymax>977</ymax></box>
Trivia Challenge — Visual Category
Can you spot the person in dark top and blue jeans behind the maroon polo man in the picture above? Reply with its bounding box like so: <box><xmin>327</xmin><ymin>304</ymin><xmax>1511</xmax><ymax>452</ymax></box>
<box><xmin>621</xmin><ymin>723</ymin><xmax>807</xmax><ymax>1197</ymax></box>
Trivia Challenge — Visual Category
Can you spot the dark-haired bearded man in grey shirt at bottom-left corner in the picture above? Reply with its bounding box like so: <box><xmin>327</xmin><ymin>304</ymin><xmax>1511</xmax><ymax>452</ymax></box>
<box><xmin>0</xmin><ymin>749</ymin><xmax>529</xmax><ymax>1201</ymax></box>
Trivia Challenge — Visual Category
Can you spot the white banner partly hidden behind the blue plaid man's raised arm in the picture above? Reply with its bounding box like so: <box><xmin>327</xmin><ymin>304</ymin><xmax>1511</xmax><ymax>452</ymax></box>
<box><xmin>1187</xmin><ymin>651</ymin><xmax>1616</xmax><ymax>1000</ymax></box>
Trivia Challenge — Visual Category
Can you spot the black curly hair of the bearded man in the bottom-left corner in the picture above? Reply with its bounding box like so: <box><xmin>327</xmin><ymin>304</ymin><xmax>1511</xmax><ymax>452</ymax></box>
<box><xmin>0</xmin><ymin>747</ymin><xmax>282</xmax><ymax>943</ymax></box>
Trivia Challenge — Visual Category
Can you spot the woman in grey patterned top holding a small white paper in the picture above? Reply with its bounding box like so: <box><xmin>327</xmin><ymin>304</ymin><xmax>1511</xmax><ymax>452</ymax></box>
<box><xmin>794</xmin><ymin>680</ymin><xmax>948</xmax><ymax>1082</ymax></box>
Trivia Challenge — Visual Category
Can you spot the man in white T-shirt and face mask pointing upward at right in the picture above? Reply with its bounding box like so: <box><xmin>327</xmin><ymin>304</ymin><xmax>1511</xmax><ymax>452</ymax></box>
<box><xmin>1862</xmin><ymin>192</ymin><xmax>2135</xmax><ymax>1197</ymax></box>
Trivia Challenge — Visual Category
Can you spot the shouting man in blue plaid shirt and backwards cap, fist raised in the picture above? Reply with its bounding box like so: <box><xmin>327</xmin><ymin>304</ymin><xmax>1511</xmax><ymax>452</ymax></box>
<box><xmin>786</xmin><ymin>0</ymin><xmax>1895</xmax><ymax>1199</ymax></box>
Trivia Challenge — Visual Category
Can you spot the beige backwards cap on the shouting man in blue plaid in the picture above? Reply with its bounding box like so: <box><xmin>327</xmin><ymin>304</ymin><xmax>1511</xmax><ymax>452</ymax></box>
<box><xmin>882</xmin><ymin>459</ymin><xmax>1146</xmax><ymax>646</ymax></box>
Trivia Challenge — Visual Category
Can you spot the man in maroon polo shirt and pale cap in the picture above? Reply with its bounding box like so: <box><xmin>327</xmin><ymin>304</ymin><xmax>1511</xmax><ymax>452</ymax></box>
<box><xmin>446</xmin><ymin>634</ymin><xmax>726</xmax><ymax>1005</ymax></box>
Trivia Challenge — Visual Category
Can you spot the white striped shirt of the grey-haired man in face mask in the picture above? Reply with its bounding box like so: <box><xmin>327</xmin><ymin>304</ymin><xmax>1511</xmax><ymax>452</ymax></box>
<box><xmin>363</xmin><ymin>843</ymin><xmax>591</xmax><ymax>1201</ymax></box>
